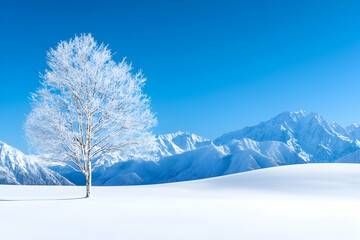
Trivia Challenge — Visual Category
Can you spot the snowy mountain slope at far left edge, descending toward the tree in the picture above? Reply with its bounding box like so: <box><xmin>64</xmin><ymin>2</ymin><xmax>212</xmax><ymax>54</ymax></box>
<box><xmin>0</xmin><ymin>142</ymin><xmax>72</xmax><ymax>185</ymax></box>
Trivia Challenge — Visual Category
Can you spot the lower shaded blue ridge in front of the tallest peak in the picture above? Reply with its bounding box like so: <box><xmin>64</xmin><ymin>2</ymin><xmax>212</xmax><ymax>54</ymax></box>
<box><xmin>94</xmin><ymin>139</ymin><xmax>305</xmax><ymax>185</ymax></box>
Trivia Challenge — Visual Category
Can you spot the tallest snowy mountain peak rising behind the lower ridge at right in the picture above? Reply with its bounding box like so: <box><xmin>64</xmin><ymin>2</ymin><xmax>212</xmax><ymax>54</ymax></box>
<box><xmin>214</xmin><ymin>111</ymin><xmax>360</xmax><ymax>162</ymax></box>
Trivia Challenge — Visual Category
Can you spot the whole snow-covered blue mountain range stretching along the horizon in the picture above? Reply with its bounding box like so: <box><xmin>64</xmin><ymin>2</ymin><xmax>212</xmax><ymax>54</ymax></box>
<box><xmin>0</xmin><ymin>111</ymin><xmax>360</xmax><ymax>185</ymax></box>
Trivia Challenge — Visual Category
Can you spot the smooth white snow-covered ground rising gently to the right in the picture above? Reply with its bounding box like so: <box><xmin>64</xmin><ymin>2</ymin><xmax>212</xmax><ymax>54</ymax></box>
<box><xmin>0</xmin><ymin>163</ymin><xmax>360</xmax><ymax>240</ymax></box>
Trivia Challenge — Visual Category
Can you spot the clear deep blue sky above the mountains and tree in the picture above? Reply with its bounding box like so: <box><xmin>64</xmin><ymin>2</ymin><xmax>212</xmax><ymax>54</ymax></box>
<box><xmin>0</xmin><ymin>0</ymin><xmax>360</xmax><ymax>152</ymax></box>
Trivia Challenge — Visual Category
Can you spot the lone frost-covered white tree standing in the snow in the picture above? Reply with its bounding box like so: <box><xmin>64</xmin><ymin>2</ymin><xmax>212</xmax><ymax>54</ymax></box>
<box><xmin>25</xmin><ymin>34</ymin><xmax>157</xmax><ymax>197</ymax></box>
